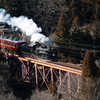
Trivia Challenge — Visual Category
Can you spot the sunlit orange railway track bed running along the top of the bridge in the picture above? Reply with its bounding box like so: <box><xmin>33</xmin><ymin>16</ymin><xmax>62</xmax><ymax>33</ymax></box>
<box><xmin>8</xmin><ymin>53</ymin><xmax>82</xmax><ymax>75</ymax></box>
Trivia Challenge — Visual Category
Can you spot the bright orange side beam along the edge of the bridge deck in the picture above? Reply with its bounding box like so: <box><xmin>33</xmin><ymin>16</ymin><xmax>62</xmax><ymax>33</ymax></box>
<box><xmin>9</xmin><ymin>53</ymin><xmax>82</xmax><ymax>75</ymax></box>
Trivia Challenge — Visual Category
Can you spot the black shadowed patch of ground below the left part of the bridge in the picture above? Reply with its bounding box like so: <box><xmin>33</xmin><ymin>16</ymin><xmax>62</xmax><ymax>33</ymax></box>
<box><xmin>9</xmin><ymin>83</ymin><xmax>33</xmax><ymax>100</ymax></box>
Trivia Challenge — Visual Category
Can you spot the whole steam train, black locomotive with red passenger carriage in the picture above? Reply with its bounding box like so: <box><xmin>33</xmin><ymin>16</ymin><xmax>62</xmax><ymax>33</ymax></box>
<box><xmin>0</xmin><ymin>36</ymin><xmax>57</xmax><ymax>60</ymax></box>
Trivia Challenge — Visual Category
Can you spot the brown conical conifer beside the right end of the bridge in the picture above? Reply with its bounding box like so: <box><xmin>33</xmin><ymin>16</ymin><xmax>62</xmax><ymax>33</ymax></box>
<box><xmin>82</xmin><ymin>50</ymin><xmax>98</xmax><ymax>77</ymax></box>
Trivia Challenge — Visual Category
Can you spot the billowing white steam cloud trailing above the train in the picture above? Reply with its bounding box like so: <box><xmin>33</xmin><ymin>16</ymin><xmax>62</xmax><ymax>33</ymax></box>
<box><xmin>0</xmin><ymin>8</ymin><xmax>50</xmax><ymax>45</ymax></box>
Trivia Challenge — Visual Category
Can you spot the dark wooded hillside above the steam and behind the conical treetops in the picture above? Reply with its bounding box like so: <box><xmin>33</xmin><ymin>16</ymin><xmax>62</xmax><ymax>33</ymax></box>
<box><xmin>0</xmin><ymin>0</ymin><xmax>100</xmax><ymax>36</ymax></box>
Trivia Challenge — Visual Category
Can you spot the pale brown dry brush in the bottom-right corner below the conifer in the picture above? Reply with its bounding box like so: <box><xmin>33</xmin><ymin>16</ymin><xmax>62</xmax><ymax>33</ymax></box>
<box><xmin>81</xmin><ymin>77</ymin><xmax>100</xmax><ymax>100</ymax></box>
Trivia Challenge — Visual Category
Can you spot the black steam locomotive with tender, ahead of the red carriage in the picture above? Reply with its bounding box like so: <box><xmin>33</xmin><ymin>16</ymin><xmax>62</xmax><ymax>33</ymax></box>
<box><xmin>19</xmin><ymin>42</ymin><xmax>57</xmax><ymax>60</ymax></box>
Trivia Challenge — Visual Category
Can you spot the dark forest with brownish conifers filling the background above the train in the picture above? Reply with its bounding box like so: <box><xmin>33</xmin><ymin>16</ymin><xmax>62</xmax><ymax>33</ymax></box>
<box><xmin>0</xmin><ymin>0</ymin><xmax>100</xmax><ymax>44</ymax></box>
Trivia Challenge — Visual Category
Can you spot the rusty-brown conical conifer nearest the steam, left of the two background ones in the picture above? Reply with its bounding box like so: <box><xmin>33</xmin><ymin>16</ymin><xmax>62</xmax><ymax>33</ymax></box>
<box><xmin>54</xmin><ymin>13</ymin><xmax>69</xmax><ymax>42</ymax></box>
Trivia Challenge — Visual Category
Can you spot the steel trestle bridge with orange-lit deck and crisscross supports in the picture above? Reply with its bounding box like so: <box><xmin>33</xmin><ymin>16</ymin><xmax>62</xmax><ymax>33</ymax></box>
<box><xmin>6</xmin><ymin>53</ymin><xmax>82</xmax><ymax>100</ymax></box>
